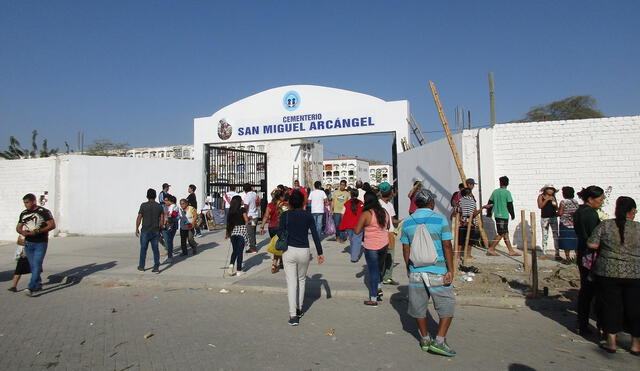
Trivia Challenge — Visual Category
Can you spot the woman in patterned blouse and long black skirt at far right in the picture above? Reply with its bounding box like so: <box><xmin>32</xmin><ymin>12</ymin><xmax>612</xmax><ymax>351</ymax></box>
<box><xmin>588</xmin><ymin>196</ymin><xmax>640</xmax><ymax>355</ymax></box>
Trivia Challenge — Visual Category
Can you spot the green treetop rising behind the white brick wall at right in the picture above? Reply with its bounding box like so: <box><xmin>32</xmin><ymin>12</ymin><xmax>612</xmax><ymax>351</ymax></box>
<box><xmin>523</xmin><ymin>95</ymin><xmax>604</xmax><ymax>121</ymax></box>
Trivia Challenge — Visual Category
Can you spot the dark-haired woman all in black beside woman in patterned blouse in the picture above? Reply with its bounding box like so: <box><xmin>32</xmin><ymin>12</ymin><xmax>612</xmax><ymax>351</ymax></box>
<box><xmin>573</xmin><ymin>185</ymin><xmax>604</xmax><ymax>335</ymax></box>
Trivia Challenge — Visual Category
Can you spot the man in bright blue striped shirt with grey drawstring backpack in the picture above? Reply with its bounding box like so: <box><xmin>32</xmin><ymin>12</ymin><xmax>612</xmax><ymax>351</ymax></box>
<box><xmin>400</xmin><ymin>188</ymin><xmax>456</xmax><ymax>357</ymax></box>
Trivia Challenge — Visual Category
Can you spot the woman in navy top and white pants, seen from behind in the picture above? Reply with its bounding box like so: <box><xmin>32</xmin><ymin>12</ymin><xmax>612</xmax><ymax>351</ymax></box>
<box><xmin>278</xmin><ymin>190</ymin><xmax>324</xmax><ymax>326</ymax></box>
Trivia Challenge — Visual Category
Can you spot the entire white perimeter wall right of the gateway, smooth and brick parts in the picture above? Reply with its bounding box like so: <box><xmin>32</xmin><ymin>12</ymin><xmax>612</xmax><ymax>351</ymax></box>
<box><xmin>398</xmin><ymin>116</ymin><xmax>640</xmax><ymax>247</ymax></box>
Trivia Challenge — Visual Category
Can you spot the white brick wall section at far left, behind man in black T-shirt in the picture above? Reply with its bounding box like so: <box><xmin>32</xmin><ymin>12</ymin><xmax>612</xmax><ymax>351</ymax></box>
<box><xmin>0</xmin><ymin>158</ymin><xmax>56</xmax><ymax>241</ymax></box>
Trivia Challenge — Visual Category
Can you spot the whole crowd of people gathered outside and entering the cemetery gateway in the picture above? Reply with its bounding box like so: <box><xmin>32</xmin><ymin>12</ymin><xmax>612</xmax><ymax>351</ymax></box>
<box><xmin>9</xmin><ymin>176</ymin><xmax>640</xmax><ymax>356</ymax></box>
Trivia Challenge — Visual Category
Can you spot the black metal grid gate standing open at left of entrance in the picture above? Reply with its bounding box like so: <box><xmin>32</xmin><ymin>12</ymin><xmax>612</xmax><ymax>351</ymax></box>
<box><xmin>205</xmin><ymin>145</ymin><xmax>268</xmax><ymax>218</ymax></box>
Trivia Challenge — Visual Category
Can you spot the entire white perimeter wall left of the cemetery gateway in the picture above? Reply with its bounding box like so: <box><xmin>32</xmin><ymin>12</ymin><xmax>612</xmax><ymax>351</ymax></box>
<box><xmin>0</xmin><ymin>156</ymin><xmax>203</xmax><ymax>240</ymax></box>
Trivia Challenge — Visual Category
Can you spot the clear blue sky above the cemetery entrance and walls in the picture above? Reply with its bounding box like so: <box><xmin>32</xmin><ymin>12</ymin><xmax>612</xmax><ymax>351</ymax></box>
<box><xmin>0</xmin><ymin>0</ymin><xmax>640</xmax><ymax>160</ymax></box>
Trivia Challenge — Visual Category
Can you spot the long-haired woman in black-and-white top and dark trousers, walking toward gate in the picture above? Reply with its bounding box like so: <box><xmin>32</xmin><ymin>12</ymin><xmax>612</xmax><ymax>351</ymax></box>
<box><xmin>224</xmin><ymin>195</ymin><xmax>249</xmax><ymax>276</ymax></box>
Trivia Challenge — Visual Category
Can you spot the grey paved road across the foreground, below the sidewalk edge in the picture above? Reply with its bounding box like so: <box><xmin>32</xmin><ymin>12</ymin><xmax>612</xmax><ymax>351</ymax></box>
<box><xmin>0</xmin><ymin>281</ymin><xmax>640</xmax><ymax>370</ymax></box>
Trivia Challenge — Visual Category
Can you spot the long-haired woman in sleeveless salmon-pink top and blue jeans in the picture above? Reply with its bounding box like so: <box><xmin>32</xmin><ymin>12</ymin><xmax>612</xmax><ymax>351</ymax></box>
<box><xmin>354</xmin><ymin>191</ymin><xmax>391</xmax><ymax>306</ymax></box>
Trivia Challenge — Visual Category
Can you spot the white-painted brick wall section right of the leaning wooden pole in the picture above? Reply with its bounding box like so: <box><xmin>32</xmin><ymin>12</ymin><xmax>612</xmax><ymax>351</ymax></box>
<box><xmin>490</xmin><ymin>116</ymin><xmax>640</xmax><ymax>250</ymax></box>
